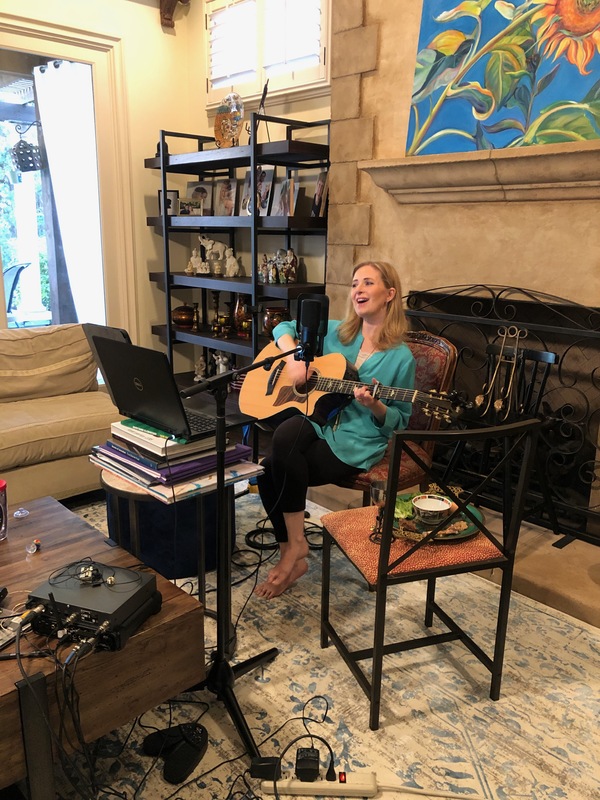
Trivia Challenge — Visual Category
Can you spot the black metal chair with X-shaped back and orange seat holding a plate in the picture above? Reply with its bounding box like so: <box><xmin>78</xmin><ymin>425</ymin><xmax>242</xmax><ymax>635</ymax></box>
<box><xmin>321</xmin><ymin>419</ymin><xmax>541</xmax><ymax>730</ymax></box>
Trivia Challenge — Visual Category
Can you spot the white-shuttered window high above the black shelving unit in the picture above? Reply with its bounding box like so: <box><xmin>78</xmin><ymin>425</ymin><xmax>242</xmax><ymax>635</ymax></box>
<box><xmin>205</xmin><ymin>0</ymin><xmax>330</xmax><ymax>106</ymax></box>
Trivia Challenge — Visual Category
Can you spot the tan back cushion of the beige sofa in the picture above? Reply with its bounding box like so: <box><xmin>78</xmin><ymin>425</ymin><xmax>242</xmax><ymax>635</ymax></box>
<box><xmin>0</xmin><ymin>324</ymin><xmax>98</xmax><ymax>404</ymax></box>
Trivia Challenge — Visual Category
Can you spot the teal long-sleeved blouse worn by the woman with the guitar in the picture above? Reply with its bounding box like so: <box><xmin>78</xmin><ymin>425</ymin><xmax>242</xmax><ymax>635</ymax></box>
<box><xmin>273</xmin><ymin>320</ymin><xmax>415</xmax><ymax>470</ymax></box>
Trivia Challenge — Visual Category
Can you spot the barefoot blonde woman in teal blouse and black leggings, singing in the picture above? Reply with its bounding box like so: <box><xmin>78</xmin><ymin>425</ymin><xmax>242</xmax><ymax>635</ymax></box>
<box><xmin>255</xmin><ymin>261</ymin><xmax>415</xmax><ymax>599</ymax></box>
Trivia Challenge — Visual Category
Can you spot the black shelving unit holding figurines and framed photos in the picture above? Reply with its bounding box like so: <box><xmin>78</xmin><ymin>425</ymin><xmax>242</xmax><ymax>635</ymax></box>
<box><xmin>144</xmin><ymin>113</ymin><xmax>329</xmax><ymax>368</ymax></box>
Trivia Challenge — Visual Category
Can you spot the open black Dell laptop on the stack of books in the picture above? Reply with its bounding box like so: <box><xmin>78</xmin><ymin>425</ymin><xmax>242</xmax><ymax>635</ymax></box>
<box><xmin>92</xmin><ymin>335</ymin><xmax>217</xmax><ymax>442</ymax></box>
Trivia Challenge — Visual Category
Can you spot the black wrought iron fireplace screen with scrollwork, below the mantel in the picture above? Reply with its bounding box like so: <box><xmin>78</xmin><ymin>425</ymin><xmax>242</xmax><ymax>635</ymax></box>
<box><xmin>405</xmin><ymin>284</ymin><xmax>600</xmax><ymax>544</ymax></box>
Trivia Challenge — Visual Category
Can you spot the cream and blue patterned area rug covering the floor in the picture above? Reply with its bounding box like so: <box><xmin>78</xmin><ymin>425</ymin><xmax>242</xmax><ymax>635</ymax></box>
<box><xmin>60</xmin><ymin>494</ymin><xmax>600</xmax><ymax>800</ymax></box>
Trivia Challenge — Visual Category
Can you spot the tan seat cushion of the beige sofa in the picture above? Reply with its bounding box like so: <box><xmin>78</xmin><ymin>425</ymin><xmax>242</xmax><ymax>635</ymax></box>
<box><xmin>0</xmin><ymin>392</ymin><xmax>122</xmax><ymax>475</ymax></box>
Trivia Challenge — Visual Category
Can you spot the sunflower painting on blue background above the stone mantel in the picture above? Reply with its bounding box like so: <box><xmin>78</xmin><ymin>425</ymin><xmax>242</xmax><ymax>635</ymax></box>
<box><xmin>406</xmin><ymin>0</ymin><xmax>600</xmax><ymax>155</ymax></box>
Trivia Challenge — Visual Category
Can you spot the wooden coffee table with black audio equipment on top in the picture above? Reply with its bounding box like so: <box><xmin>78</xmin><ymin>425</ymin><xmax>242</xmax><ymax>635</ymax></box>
<box><xmin>0</xmin><ymin>497</ymin><xmax>205</xmax><ymax>800</ymax></box>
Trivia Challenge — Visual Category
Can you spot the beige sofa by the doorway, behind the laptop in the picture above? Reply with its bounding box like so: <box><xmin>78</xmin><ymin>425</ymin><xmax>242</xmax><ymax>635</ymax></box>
<box><xmin>0</xmin><ymin>325</ymin><xmax>121</xmax><ymax>504</ymax></box>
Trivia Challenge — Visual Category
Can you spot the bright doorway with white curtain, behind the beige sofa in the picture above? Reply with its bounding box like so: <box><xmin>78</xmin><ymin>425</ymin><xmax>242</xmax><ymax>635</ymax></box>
<box><xmin>0</xmin><ymin>50</ymin><xmax>106</xmax><ymax>327</ymax></box>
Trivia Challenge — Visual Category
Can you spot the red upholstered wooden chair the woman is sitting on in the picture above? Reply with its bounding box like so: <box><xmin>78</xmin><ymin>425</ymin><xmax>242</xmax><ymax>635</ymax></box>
<box><xmin>336</xmin><ymin>331</ymin><xmax>457</xmax><ymax>506</ymax></box>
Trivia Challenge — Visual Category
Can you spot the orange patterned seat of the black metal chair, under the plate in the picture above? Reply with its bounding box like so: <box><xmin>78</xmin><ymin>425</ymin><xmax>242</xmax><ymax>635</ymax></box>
<box><xmin>321</xmin><ymin>506</ymin><xmax>504</xmax><ymax>587</ymax></box>
